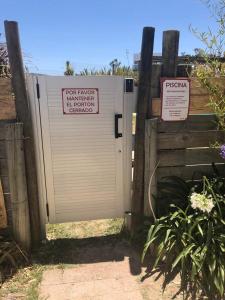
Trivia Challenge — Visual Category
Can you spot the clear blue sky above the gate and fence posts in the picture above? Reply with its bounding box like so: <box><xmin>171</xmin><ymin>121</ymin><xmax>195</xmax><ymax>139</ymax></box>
<box><xmin>0</xmin><ymin>0</ymin><xmax>218</xmax><ymax>74</ymax></box>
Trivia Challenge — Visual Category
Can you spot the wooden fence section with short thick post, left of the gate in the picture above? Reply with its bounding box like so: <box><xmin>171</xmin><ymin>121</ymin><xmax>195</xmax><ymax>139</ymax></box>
<box><xmin>0</xmin><ymin>78</ymin><xmax>30</xmax><ymax>250</ymax></box>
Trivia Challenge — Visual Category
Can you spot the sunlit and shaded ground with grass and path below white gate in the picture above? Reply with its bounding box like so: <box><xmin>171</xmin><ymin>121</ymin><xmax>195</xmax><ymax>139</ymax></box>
<box><xmin>1</xmin><ymin>220</ymin><xmax>183</xmax><ymax>300</ymax></box>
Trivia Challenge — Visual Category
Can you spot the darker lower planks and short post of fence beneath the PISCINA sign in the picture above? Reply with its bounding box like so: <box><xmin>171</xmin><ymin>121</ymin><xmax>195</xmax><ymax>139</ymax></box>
<box><xmin>145</xmin><ymin>114</ymin><xmax>225</xmax><ymax>214</ymax></box>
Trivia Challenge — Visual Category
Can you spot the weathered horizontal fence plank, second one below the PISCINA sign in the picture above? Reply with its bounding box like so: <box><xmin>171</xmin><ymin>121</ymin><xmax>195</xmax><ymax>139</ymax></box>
<box><xmin>158</xmin><ymin>130</ymin><xmax>225</xmax><ymax>150</ymax></box>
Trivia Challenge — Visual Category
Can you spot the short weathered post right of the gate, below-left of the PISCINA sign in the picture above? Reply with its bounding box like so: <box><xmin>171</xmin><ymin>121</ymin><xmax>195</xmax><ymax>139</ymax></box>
<box><xmin>144</xmin><ymin>118</ymin><xmax>158</xmax><ymax>217</ymax></box>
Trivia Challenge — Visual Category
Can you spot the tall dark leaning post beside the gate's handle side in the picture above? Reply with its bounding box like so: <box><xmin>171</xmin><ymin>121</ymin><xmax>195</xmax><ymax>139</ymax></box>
<box><xmin>131</xmin><ymin>27</ymin><xmax>155</xmax><ymax>233</ymax></box>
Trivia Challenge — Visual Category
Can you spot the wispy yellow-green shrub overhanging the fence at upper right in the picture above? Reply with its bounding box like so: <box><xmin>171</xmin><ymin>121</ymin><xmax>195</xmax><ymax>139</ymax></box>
<box><xmin>191</xmin><ymin>0</ymin><xmax>225</xmax><ymax>130</ymax></box>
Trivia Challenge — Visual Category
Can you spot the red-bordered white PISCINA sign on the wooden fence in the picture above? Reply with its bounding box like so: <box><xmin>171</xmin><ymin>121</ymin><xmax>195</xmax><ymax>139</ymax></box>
<box><xmin>161</xmin><ymin>78</ymin><xmax>190</xmax><ymax>121</ymax></box>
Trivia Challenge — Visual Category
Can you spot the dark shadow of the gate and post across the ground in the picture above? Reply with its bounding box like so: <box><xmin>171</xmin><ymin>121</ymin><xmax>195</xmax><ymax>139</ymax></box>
<box><xmin>32</xmin><ymin>234</ymin><xmax>141</xmax><ymax>275</ymax></box>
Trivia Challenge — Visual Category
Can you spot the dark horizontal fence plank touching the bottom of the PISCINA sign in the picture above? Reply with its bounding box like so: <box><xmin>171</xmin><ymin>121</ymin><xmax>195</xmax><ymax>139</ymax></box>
<box><xmin>158</xmin><ymin>115</ymin><xmax>217</xmax><ymax>132</ymax></box>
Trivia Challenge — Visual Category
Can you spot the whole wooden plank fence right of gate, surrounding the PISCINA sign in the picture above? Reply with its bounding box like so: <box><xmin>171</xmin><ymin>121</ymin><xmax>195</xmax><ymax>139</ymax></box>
<box><xmin>144</xmin><ymin>64</ymin><xmax>225</xmax><ymax>215</ymax></box>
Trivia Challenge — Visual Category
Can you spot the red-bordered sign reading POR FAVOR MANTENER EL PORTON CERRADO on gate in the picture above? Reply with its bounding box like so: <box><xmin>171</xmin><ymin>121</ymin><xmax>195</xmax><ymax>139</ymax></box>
<box><xmin>62</xmin><ymin>88</ymin><xmax>99</xmax><ymax>114</ymax></box>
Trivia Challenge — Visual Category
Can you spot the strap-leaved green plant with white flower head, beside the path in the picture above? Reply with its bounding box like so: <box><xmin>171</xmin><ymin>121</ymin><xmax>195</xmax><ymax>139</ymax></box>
<box><xmin>143</xmin><ymin>177</ymin><xmax>225</xmax><ymax>300</ymax></box>
